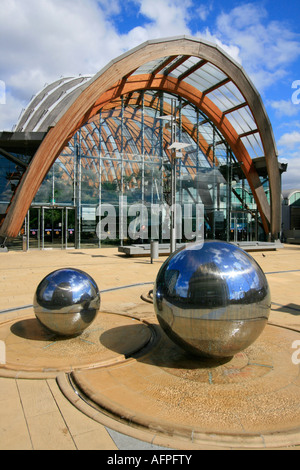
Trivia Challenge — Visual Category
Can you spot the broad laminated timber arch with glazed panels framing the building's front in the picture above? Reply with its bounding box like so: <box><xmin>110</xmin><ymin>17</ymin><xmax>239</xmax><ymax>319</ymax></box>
<box><xmin>0</xmin><ymin>37</ymin><xmax>281</xmax><ymax>239</ymax></box>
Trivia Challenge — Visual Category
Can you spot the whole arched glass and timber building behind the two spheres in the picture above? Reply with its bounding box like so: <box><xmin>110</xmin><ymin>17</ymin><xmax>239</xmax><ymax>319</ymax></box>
<box><xmin>0</xmin><ymin>38</ymin><xmax>282</xmax><ymax>249</ymax></box>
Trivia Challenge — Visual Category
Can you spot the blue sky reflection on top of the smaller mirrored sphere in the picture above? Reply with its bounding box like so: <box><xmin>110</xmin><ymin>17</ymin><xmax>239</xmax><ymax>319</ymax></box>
<box><xmin>41</xmin><ymin>269</ymin><xmax>92</xmax><ymax>303</ymax></box>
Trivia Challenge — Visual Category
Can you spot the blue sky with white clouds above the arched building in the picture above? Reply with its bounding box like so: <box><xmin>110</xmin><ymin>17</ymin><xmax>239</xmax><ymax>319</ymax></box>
<box><xmin>0</xmin><ymin>0</ymin><xmax>300</xmax><ymax>135</ymax></box>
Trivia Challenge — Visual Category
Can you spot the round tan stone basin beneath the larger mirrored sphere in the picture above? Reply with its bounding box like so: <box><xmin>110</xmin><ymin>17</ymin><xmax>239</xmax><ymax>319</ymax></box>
<box><xmin>71</xmin><ymin>324</ymin><xmax>300</xmax><ymax>449</ymax></box>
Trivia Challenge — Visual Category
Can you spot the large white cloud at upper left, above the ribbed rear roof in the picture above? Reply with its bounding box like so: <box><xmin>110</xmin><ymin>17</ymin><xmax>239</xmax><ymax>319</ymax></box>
<box><xmin>0</xmin><ymin>0</ymin><xmax>127</xmax><ymax>129</ymax></box>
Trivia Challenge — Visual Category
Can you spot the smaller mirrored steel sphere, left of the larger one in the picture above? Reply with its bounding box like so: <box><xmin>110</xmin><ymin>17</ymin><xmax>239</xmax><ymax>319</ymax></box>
<box><xmin>33</xmin><ymin>268</ymin><xmax>100</xmax><ymax>336</ymax></box>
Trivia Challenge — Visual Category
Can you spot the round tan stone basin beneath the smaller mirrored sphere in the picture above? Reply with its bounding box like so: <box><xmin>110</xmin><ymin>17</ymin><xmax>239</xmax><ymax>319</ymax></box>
<box><xmin>0</xmin><ymin>313</ymin><xmax>152</xmax><ymax>376</ymax></box>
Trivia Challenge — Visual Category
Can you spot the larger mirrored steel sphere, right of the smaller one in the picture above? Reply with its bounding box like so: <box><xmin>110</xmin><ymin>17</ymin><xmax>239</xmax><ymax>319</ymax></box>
<box><xmin>153</xmin><ymin>241</ymin><xmax>271</xmax><ymax>358</ymax></box>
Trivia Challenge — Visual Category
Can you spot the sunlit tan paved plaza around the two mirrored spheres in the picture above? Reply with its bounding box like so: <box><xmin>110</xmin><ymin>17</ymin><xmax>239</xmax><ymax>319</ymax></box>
<box><xmin>0</xmin><ymin>245</ymin><xmax>300</xmax><ymax>450</ymax></box>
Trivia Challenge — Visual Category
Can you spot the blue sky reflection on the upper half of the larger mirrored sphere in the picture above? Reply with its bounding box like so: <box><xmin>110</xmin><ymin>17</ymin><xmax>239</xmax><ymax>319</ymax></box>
<box><xmin>166</xmin><ymin>241</ymin><xmax>264</xmax><ymax>300</ymax></box>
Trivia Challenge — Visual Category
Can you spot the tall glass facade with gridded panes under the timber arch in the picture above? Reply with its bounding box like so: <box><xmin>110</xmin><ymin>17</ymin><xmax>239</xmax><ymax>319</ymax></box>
<box><xmin>0</xmin><ymin>91</ymin><xmax>268</xmax><ymax>249</ymax></box>
